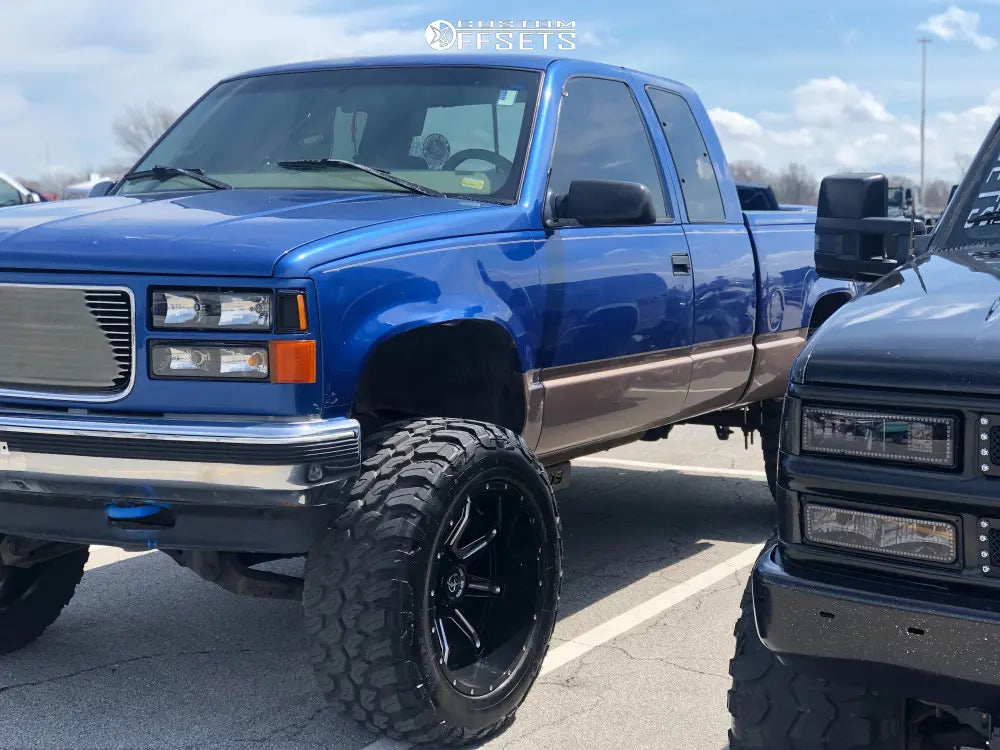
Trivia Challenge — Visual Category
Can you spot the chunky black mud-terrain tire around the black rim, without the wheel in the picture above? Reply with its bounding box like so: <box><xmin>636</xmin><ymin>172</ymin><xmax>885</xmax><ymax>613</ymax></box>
<box><xmin>303</xmin><ymin>418</ymin><xmax>561</xmax><ymax>746</ymax></box>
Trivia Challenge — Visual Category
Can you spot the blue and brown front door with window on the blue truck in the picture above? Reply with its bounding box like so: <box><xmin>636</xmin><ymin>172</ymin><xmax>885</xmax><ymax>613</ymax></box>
<box><xmin>537</xmin><ymin>76</ymin><xmax>693</xmax><ymax>456</ymax></box>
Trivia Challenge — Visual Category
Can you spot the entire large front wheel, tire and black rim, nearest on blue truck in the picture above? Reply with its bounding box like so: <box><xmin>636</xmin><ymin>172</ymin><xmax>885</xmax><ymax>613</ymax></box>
<box><xmin>304</xmin><ymin>419</ymin><xmax>561</xmax><ymax>745</ymax></box>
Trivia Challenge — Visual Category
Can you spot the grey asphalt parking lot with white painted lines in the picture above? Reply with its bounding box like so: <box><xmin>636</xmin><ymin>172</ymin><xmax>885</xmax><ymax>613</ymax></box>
<box><xmin>0</xmin><ymin>427</ymin><xmax>773</xmax><ymax>750</ymax></box>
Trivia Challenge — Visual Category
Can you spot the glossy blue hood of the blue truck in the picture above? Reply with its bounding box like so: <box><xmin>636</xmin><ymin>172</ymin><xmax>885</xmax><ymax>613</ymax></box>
<box><xmin>0</xmin><ymin>190</ymin><xmax>510</xmax><ymax>276</ymax></box>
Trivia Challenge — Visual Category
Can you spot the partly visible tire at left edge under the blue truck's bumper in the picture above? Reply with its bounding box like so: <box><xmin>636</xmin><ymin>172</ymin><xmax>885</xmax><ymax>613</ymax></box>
<box><xmin>0</xmin><ymin>548</ymin><xmax>89</xmax><ymax>654</ymax></box>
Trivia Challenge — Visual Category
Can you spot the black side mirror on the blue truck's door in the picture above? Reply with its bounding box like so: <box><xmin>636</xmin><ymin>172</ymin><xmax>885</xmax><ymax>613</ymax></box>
<box><xmin>552</xmin><ymin>180</ymin><xmax>656</xmax><ymax>226</ymax></box>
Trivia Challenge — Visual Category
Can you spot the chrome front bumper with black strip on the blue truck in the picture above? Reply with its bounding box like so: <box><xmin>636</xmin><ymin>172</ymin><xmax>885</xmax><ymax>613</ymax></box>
<box><xmin>0</xmin><ymin>412</ymin><xmax>361</xmax><ymax>507</ymax></box>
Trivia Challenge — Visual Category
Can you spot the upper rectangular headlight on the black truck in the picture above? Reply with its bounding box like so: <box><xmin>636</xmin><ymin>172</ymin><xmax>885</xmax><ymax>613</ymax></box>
<box><xmin>802</xmin><ymin>406</ymin><xmax>956</xmax><ymax>467</ymax></box>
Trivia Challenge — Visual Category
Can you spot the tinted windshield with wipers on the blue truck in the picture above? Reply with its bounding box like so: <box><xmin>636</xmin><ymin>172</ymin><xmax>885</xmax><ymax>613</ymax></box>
<box><xmin>118</xmin><ymin>67</ymin><xmax>540</xmax><ymax>202</ymax></box>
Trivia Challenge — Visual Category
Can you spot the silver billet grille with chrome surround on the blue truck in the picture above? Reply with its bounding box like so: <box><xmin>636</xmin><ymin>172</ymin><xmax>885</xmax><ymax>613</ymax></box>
<box><xmin>0</xmin><ymin>284</ymin><xmax>134</xmax><ymax>400</ymax></box>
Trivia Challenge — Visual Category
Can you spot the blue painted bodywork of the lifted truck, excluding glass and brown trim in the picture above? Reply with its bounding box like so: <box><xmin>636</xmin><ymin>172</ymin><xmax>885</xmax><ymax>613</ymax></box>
<box><xmin>0</xmin><ymin>55</ymin><xmax>854</xmax><ymax>426</ymax></box>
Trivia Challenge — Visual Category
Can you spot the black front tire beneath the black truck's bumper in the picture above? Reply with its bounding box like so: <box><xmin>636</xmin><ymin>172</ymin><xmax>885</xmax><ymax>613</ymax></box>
<box><xmin>729</xmin><ymin>583</ymin><xmax>906</xmax><ymax>750</ymax></box>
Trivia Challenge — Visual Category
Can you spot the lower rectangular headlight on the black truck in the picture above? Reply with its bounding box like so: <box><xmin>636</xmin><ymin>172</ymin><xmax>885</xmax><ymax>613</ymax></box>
<box><xmin>805</xmin><ymin>503</ymin><xmax>957</xmax><ymax>563</ymax></box>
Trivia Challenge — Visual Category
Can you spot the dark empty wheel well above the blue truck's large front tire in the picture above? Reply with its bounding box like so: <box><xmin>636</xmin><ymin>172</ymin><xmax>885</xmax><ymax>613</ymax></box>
<box><xmin>353</xmin><ymin>320</ymin><xmax>526</xmax><ymax>434</ymax></box>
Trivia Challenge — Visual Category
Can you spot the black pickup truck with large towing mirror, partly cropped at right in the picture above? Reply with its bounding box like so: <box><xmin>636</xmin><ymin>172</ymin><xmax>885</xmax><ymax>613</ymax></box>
<box><xmin>729</xmin><ymin>114</ymin><xmax>1000</xmax><ymax>750</ymax></box>
